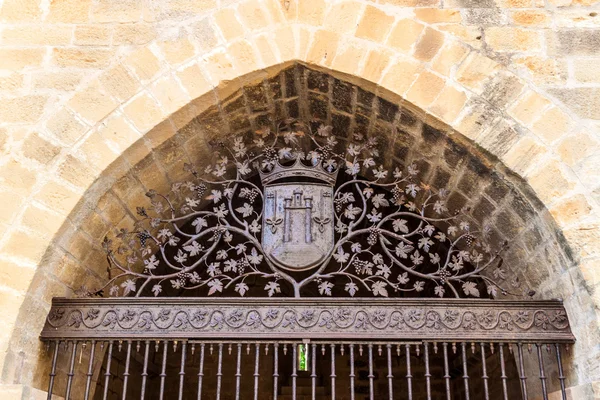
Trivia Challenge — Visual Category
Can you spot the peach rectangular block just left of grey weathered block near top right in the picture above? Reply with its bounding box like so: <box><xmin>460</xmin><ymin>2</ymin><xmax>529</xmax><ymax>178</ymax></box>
<box><xmin>485</xmin><ymin>26</ymin><xmax>542</xmax><ymax>53</ymax></box>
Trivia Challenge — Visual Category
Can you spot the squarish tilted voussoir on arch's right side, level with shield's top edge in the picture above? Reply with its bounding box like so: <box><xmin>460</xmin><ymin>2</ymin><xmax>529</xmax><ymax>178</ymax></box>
<box><xmin>527</xmin><ymin>160</ymin><xmax>575</xmax><ymax>204</ymax></box>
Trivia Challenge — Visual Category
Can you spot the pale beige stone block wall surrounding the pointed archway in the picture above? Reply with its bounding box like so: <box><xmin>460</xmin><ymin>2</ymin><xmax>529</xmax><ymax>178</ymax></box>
<box><xmin>0</xmin><ymin>0</ymin><xmax>600</xmax><ymax>398</ymax></box>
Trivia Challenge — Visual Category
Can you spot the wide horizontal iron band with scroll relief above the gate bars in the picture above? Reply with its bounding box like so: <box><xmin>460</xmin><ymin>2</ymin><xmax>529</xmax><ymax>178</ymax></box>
<box><xmin>41</xmin><ymin>298</ymin><xmax>575</xmax><ymax>343</ymax></box>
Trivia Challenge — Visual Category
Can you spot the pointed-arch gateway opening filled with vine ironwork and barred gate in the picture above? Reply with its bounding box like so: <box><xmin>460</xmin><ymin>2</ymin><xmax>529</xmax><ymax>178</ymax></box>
<box><xmin>30</xmin><ymin>65</ymin><xmax>573</xmax><ymax>399</ymax></box>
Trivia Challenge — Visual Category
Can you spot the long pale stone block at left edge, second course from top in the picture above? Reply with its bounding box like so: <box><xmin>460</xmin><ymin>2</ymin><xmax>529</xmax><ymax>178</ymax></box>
<box><xmin>0</xmin><ymin>25</ymin><xmax>73</xmax><ymax>46</ymax></box>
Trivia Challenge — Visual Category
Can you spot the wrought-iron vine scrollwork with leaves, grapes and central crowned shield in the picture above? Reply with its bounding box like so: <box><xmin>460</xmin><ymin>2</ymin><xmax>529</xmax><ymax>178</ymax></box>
<box><xmin>96</xmin><ymin>121</ymin><xmax>507</xmax><ymax>297</ymax></box>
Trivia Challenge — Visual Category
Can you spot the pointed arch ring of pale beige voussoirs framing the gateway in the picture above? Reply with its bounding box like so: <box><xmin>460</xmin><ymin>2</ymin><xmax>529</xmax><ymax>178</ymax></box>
<box><xmin>3</xmin><ymin>2</ymin><xmax>597</xmax><ymax>394</ymax></box>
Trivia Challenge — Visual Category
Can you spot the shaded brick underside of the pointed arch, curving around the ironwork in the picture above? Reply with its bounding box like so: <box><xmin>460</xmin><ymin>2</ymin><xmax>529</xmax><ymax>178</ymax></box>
<box><xmin>3</xmin><ymin>63</ymin><xmax>596</xmax><ymax>396</ymax></box>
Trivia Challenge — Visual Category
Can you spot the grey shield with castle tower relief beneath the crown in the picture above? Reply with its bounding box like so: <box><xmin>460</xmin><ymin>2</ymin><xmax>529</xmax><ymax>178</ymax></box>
<box><xmin>262</xmin><ymin>183</ymin><xmax>334</xmax><ymax>271</ymax></box>
